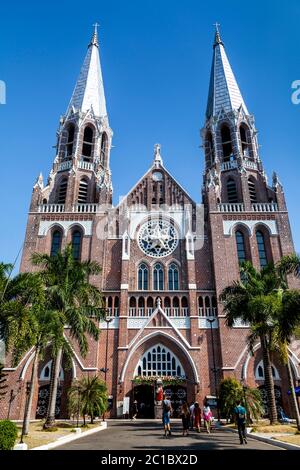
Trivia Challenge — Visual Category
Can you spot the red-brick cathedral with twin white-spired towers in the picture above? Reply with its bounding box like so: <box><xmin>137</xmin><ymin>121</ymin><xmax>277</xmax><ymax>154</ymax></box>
<box><xmin>1</xmin><ymin>28</ymin><xmax>300</xmax><ymax>419</ymax></box>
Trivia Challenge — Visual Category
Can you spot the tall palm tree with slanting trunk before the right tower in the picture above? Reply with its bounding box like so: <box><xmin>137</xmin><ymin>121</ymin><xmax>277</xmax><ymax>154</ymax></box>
<box><xmin>220</xmin><ymin>261</ymin><xmax>281</xmax><ymax>424</ymax></box>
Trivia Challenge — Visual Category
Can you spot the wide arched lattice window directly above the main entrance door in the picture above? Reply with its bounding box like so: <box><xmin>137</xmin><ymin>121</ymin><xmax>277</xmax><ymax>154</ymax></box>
<box><xmin>135</xmin><ymin>344</ymin><xmax>185</xmax><ymax>378</ymax></box>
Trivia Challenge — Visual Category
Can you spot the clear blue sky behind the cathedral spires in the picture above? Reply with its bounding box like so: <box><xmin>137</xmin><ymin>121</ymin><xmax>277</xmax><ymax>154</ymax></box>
<box><xmin>0</xmin><ymin>0</ymin><xmax>300</xmax><ymax>268</ymax></box>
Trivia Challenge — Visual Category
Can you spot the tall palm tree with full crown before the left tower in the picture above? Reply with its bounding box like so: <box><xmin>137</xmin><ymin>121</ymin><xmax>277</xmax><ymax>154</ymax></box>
<box><xmin>32</xmin><ymin>245</ymin><xmax>105</xmax><ymax>427</ymax></box>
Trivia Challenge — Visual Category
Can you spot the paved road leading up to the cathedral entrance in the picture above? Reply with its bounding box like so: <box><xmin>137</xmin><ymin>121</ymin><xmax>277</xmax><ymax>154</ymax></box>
<box><xmin>56</xmin><ymin>420</ymin><xmax>280</xmax><ymax>451</ymax></box>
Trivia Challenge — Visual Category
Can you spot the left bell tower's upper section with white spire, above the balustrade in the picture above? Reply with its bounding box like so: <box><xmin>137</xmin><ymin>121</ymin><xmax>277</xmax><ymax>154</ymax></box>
<box><xmin>34</xmin><ymin>24</ymin><xmax>113</xmax><ymax>211</ymax></box>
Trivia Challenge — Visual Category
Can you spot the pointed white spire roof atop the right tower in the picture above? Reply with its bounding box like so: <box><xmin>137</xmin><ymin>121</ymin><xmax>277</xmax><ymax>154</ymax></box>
<box><xmin>206</xmin><ymin>27</ymin><xmax>249</xmax><ymax>119</ymax></box>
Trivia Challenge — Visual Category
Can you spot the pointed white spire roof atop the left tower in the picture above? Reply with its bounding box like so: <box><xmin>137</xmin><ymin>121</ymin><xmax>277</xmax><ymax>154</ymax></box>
<box><xmin>67</xmin><ymin>24</ymin><xmax>107</xmax><ymax>117</ymax></box>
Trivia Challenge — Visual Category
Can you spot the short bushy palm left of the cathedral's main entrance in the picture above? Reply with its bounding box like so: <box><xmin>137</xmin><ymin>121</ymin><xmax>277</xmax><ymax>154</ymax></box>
<box><xmin>69</xmin><ymin>375</ymin><xmax>108</xmax><ymax>425</ymax></box>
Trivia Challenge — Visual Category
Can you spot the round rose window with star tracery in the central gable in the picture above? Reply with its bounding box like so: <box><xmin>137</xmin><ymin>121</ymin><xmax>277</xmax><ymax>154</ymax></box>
<box><xmin>138</xmin><ymin>220</ymin><xmax>178</xmax><ymax>258</ymax></box>
